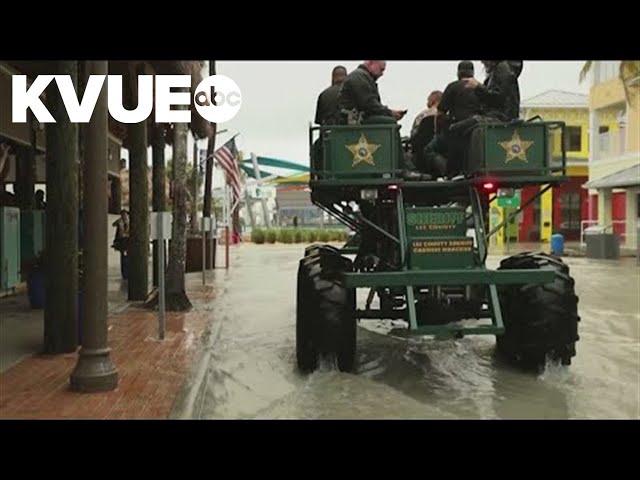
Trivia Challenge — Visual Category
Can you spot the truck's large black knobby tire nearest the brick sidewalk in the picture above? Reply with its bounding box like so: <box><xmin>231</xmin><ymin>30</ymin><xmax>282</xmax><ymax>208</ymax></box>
<box><xmin>296</xmin><ymin>246</ymin><xmax>356</xmax><ymax>373</ymax></box>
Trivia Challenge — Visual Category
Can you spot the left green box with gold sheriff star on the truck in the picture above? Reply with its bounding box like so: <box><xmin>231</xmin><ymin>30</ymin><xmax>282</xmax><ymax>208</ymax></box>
<box><xmin>319</xmin><ymin>124</ymin><xmax>402</xmax><ymax>179</ymax></box>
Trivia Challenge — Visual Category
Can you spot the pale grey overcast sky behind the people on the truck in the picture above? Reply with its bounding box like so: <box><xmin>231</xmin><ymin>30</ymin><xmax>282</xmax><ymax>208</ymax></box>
<box><xmin>216</xmin><ymin>60</ymin><xmax>589</xmax><ymax>173</ymax></box>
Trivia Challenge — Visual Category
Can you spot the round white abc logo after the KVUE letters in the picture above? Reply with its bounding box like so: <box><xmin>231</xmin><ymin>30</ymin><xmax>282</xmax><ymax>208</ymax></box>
<box><xmin>194</xmin><ymin>75</ymin><xmax>242</xmax><ymax>123</ymax></box>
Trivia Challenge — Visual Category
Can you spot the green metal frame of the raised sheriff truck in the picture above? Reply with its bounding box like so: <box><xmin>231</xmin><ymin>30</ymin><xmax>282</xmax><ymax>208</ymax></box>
<box><xmin>309</xmin><ymin>122</ymin><xmax>567</xmax><ymax>338</ymax></box>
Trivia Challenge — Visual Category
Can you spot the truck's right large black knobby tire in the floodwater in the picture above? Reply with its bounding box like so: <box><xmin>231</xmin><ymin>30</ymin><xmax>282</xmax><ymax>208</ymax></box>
<box><xmin>496</xmin><ymin>252</ymin><xmax>580</xmax><ymax>371</ymax></box>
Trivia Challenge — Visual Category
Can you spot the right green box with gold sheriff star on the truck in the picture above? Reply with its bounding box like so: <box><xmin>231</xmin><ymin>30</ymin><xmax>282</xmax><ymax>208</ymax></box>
<box><xmin>469</xmin><ymin>122</ymin><xmax>551</xmax><ymax>177</ymax></box>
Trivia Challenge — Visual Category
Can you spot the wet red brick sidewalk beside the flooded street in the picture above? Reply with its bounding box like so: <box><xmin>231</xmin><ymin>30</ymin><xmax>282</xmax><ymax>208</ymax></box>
<box><xmin>0</xmin><ymin>287</ymin><xmax>214</xmax><ymax>419</ymax></box>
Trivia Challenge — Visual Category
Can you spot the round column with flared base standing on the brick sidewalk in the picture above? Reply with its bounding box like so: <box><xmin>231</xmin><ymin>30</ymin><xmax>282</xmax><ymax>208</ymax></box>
<box><xmin>70</xmin><ymin>61</ymin><xmax>118</xmax><ymax>392</ymax></box>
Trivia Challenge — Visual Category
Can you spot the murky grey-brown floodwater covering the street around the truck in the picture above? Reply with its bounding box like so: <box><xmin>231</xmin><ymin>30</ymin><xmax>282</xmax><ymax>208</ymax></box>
<box><xmin>172</xmin><ymin>244</ymin><xmax>640</xmax><ymax>419</ymax></box>
